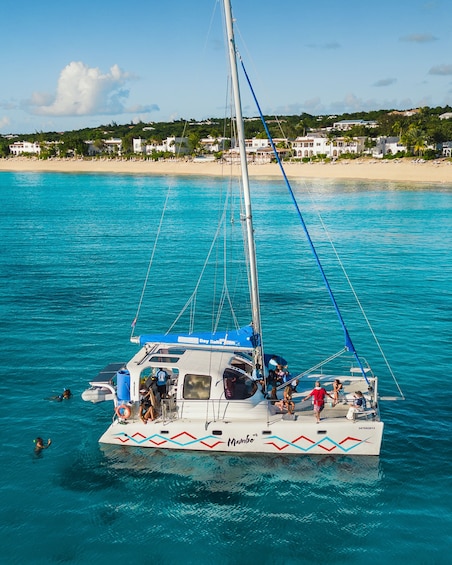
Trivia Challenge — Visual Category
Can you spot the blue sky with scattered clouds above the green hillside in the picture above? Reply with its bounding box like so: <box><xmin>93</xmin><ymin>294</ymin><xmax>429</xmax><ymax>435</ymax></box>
<box><xmin>0</xmin><ymin>0</ymin><xmax>452</xmax><ymax>135</ymax></box>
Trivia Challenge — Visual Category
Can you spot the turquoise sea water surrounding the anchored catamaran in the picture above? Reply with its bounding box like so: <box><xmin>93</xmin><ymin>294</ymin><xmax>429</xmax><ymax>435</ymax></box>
<box><xmin>0</xmin><ymin>173</ymin><xmax>452</xmax><ymax>565</ymax></box>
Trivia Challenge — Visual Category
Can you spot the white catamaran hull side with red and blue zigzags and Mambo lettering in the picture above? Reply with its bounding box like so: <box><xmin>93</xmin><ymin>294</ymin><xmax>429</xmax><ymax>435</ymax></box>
<box><xmin>100</xmin><ymin>410</ymin><xmax>383</xmax><ymax>455</ymax></box>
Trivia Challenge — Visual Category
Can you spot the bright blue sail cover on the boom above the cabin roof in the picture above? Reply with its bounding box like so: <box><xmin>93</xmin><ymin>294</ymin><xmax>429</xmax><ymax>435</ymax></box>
<box><xmin>140</xmin><ymin>326</ymin><xmax>257</xmax><ymax>349</ymax></box>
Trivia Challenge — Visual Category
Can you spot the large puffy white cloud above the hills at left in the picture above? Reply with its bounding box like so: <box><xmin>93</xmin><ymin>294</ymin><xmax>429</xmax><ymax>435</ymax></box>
<box><xmin>26</xmin><ymin>61</ymin><xmax>145</xmax><ymax>116</ymax></box>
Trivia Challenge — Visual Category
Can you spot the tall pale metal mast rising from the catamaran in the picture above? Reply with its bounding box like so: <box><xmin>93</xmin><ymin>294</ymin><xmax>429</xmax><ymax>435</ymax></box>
<box><xmin>223</xmin><ymin>0</ymin><xmax>263</xmax><ymax>369</ymax></box>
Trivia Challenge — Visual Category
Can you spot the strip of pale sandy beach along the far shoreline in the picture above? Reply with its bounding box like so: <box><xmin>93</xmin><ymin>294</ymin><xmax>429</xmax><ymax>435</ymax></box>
<box><xmin>0</xmin><ymin>157</ymin><xmax>452</xmax><ymax>184</ymax></box>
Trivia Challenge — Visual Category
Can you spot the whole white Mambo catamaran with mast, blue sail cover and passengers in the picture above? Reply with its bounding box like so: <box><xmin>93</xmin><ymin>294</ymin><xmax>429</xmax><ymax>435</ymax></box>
<box><xmin>82</xmin><ymin>0</ymin><xmax>400</xmax><ymax>455</ymax></box>
